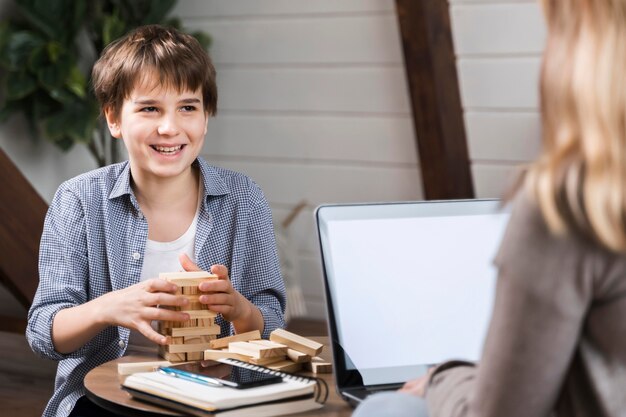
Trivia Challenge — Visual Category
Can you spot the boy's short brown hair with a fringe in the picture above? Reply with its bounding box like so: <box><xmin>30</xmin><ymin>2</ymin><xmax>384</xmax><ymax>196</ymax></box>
<box><xmin>91</xmin><ymin>25</ymin><xmax>217</xmax><ymax>117</ymax></box>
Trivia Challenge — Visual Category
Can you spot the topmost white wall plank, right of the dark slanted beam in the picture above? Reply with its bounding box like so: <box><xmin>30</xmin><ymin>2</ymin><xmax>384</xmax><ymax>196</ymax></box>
<box><xmin>450</xmin><ymin>3</ymin><xmax>545</xmax><ymax>56</ymax></box>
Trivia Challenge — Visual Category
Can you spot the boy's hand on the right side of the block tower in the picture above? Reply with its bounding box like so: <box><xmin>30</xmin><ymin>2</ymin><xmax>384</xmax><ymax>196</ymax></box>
<box><xmin>179</xmin><ymin>250</ymin><xmax>254</xmax><ymax>322</ymax></box>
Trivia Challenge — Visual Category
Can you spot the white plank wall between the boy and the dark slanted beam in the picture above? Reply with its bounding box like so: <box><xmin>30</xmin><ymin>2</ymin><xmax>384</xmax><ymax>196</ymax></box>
<box><xmin>176</xmin><ymin>0</ymin><xmax>422</xmax><ymax>318</ymax></box>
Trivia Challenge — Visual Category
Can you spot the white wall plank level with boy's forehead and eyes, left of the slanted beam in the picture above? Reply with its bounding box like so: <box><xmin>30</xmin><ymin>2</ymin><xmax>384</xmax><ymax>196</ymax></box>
<box><xmin>218</xmin><ymin>66</ymin><xmax>410</xmax><ymax>117</ymax></box>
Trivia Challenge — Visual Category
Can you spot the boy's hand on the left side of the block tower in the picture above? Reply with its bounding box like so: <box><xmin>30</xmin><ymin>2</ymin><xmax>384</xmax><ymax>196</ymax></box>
<box><xmin>101</xmin><ymin>278</ymin><xmax>189</xmax><ymax>345</ymax></box>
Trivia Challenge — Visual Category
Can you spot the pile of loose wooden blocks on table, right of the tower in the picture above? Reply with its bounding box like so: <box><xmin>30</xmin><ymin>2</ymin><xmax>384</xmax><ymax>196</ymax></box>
<box><xmin>204</xmin><ymin>329</ymin><xmax>332</xmax><ymax>373</ymax></box>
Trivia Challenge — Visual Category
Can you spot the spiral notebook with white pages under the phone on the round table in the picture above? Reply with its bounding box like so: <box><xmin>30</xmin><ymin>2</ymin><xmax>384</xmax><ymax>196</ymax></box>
<box><xmin>122</xmin><ymin>359</ymin><xmax>328</xmax><ymax>417</ymax></box>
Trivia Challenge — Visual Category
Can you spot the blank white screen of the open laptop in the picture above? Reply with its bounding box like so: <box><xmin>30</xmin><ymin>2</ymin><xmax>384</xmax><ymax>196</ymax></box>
<box><xmin>326</xmin><ymin>213</ymin><xmax>508</xmax><ymax>384</ymax></box>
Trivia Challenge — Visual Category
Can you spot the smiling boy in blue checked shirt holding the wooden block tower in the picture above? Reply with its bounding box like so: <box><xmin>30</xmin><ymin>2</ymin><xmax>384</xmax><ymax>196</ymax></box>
<box><xmin>27</xmin><ymin>26</ymin><xmax>285</xmax><ymax>416</ymax></box>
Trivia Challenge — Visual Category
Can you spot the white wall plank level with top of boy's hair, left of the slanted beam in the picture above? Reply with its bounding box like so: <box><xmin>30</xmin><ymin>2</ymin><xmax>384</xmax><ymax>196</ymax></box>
<box><xmin>187</xmin><ymin>14</ymin><xmax>402</xmax><ymax>66</ymax></box>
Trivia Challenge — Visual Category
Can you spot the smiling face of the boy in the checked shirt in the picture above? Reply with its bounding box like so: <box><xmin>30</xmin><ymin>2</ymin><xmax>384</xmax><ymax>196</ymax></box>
<box><xmin>105</xmin><ymin>77</ymin><xmax>208</xmax><ymax>181</ymax></box>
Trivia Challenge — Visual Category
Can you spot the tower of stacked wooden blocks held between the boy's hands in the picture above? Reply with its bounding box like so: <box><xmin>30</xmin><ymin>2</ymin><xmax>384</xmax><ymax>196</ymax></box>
<box><xmin>158</xmin><ymin>271</ymin><xmax>221</xmax><ymax>362</ymax></box>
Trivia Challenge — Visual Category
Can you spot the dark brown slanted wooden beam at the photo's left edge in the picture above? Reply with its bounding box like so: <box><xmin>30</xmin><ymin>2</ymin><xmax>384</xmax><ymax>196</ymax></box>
<box><xmin>0</xmin><ymin>149</ymin><xmax>48</xmax><ymax>308</ymax></box>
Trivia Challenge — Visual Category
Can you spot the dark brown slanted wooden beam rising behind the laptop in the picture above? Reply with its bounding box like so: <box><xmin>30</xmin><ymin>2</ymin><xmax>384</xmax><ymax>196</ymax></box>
<box><xmin>396</xmin><ymin>0</ymin><xmax>474</xmax><ymax>200</ymax></box>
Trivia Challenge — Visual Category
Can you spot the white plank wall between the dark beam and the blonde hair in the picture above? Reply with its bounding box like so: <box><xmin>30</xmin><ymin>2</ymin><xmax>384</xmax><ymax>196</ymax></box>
<box><xmin>449</xmin><ymin>0</ymin><xmax>545</xmax><ymax>197</ymax></box>
